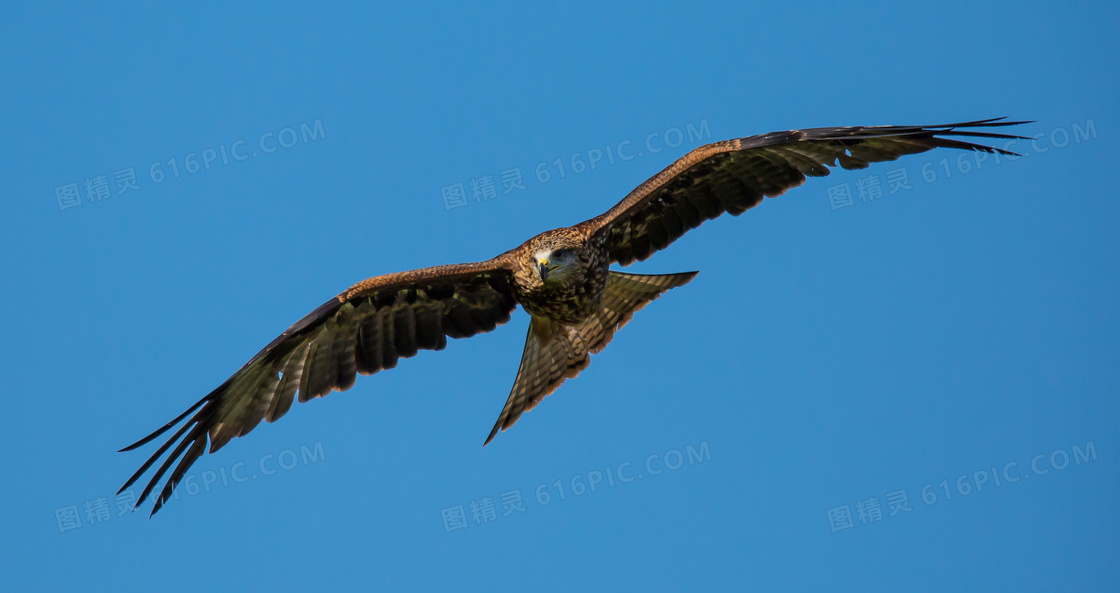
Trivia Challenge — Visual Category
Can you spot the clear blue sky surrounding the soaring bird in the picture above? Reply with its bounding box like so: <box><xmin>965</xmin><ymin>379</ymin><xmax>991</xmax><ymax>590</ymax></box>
<box><xmin>0</xmin><ymin>2</ymin><xmax>1120</xmax><ymax>591</ymax></box>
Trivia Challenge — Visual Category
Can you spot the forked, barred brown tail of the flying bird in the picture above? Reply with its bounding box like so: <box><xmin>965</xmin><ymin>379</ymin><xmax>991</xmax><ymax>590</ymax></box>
<box><xmin>483</xmin><ymin>271</ymin><xmax>698</xmax><ymax>446</ymax></box>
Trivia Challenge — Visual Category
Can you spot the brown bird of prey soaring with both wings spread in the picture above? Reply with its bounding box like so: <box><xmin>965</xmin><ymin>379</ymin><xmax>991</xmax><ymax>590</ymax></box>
<box><xmin>121</xmin><ymin>118</ymin><xmax>1029</xmax><ymax>515</ymax></box>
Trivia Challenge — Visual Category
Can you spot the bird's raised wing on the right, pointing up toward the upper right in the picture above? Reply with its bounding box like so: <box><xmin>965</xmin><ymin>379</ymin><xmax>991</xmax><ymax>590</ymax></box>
<box><xmin>579</xmin><ymin>118</ymin><xmax>1029</xmax><ymax>266</ymax></box>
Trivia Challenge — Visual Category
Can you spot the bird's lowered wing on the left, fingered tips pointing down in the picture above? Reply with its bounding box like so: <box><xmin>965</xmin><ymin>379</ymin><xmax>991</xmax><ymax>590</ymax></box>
<box><xmin>121</xmin><ymin>257</ymin><xmax>516</xmax><ymax>515</ymax></box>
